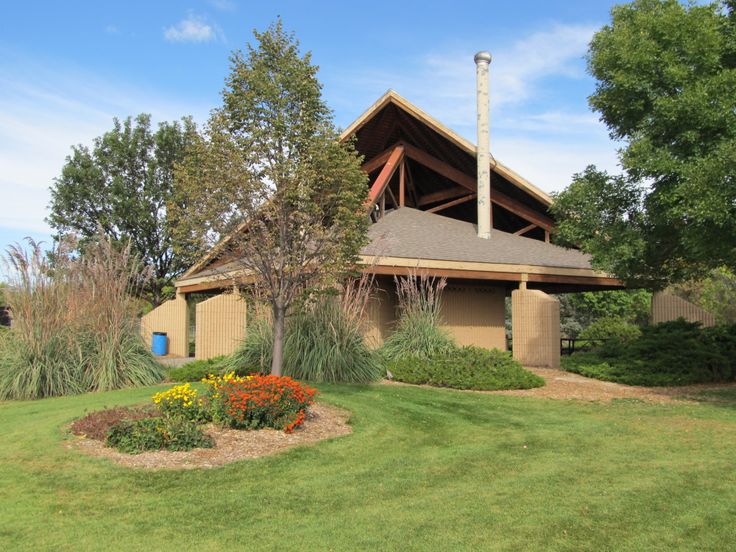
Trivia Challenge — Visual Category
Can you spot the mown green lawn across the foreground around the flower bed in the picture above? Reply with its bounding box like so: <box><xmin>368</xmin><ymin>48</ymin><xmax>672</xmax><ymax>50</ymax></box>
<box><xmin>0</xmin><ymin>385</ymin><xmax>736</xmax><ymax>551</ymax></box>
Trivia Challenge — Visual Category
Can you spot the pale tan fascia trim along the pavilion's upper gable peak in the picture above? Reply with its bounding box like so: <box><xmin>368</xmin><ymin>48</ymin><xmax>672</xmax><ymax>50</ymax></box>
<box><xmin>340</xmin><ymin>90</ymin><xmax>552</xmax><ymax>207</ymax></box>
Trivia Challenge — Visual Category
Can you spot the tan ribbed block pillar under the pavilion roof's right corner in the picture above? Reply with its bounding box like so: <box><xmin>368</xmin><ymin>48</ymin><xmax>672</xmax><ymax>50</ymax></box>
<box><xmin>511</xmin><ymin>284</ymin><xmax>560</xmax><ymax>368</ymax></box>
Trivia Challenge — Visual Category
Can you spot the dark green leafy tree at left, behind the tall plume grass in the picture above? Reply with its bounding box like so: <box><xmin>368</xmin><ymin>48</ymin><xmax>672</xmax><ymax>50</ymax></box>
<box><xmin>48</xmin><ymin>114</ymin><xmax>197</xmax><ymax>306</ymax></box>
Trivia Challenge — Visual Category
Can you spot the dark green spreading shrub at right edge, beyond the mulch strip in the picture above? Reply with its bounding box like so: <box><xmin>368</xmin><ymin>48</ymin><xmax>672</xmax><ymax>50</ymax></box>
<box><xmin>563</xmin><ymin>319</ymin><xmax>736</xmax><ymax>386</ymax></box>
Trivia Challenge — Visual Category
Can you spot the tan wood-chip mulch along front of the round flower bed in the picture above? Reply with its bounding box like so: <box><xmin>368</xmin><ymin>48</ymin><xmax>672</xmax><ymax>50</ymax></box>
<box><xmin>67</xmin><ymin>404</ymin><xmax>352</xmax><ymax>470</ymax></box>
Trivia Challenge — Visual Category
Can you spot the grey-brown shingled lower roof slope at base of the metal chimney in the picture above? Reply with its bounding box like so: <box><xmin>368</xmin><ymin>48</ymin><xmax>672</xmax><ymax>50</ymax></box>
<box><xmin>361</xmin><ymin>207</ymin><xmax>591</xmax><ymax>269</ymax></box>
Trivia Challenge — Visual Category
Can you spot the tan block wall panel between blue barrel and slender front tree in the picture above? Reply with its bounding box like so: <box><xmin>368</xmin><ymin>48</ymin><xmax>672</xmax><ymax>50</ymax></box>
<box><xmin>194</xmin><ymin>293</ymin><xmax>248</xmax><ymax>359</ymax></box>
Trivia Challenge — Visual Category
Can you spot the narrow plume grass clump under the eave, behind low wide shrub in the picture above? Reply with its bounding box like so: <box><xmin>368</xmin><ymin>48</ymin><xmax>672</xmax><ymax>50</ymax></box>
<box><xmin>380</xmin><ymin>273</ymin><xmax>456</xmax><ymax>360</ymax></box>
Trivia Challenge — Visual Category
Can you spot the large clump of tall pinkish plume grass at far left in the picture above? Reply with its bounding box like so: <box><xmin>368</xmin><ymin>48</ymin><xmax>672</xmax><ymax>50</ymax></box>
<box><xmin>0</xmin><ymin>236</ymin><xmax>162</xmax><ymax>399</ymax></box>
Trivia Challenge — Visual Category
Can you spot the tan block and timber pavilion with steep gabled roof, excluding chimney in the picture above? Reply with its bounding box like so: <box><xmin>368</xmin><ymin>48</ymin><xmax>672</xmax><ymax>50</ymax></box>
<box><xmin>144</xmin><ymin>91</ymin><xmax>622</xmax><ymax>365</ymax></box>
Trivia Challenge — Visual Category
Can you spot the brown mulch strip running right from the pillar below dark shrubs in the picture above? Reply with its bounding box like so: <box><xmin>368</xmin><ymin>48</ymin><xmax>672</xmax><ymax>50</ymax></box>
<box><xmin>487</xmin><ymin>368</ymin><xmax>736</xmax><ymax>403</ymax></box>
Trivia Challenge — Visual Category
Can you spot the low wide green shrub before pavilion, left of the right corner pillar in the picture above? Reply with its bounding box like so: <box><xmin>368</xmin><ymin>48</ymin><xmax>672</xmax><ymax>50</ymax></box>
<box><xmin>388</xmin><ymin>347</ymin><xmax>544</xmax><ymax>390</ymax></box>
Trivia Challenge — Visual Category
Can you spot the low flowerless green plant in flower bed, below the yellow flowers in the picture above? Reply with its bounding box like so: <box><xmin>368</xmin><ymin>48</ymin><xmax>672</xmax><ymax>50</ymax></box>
<box><xmin>105</xmin><ymin>416</ymin><xmax>214</xmax><ymax>454</ymax></box>
